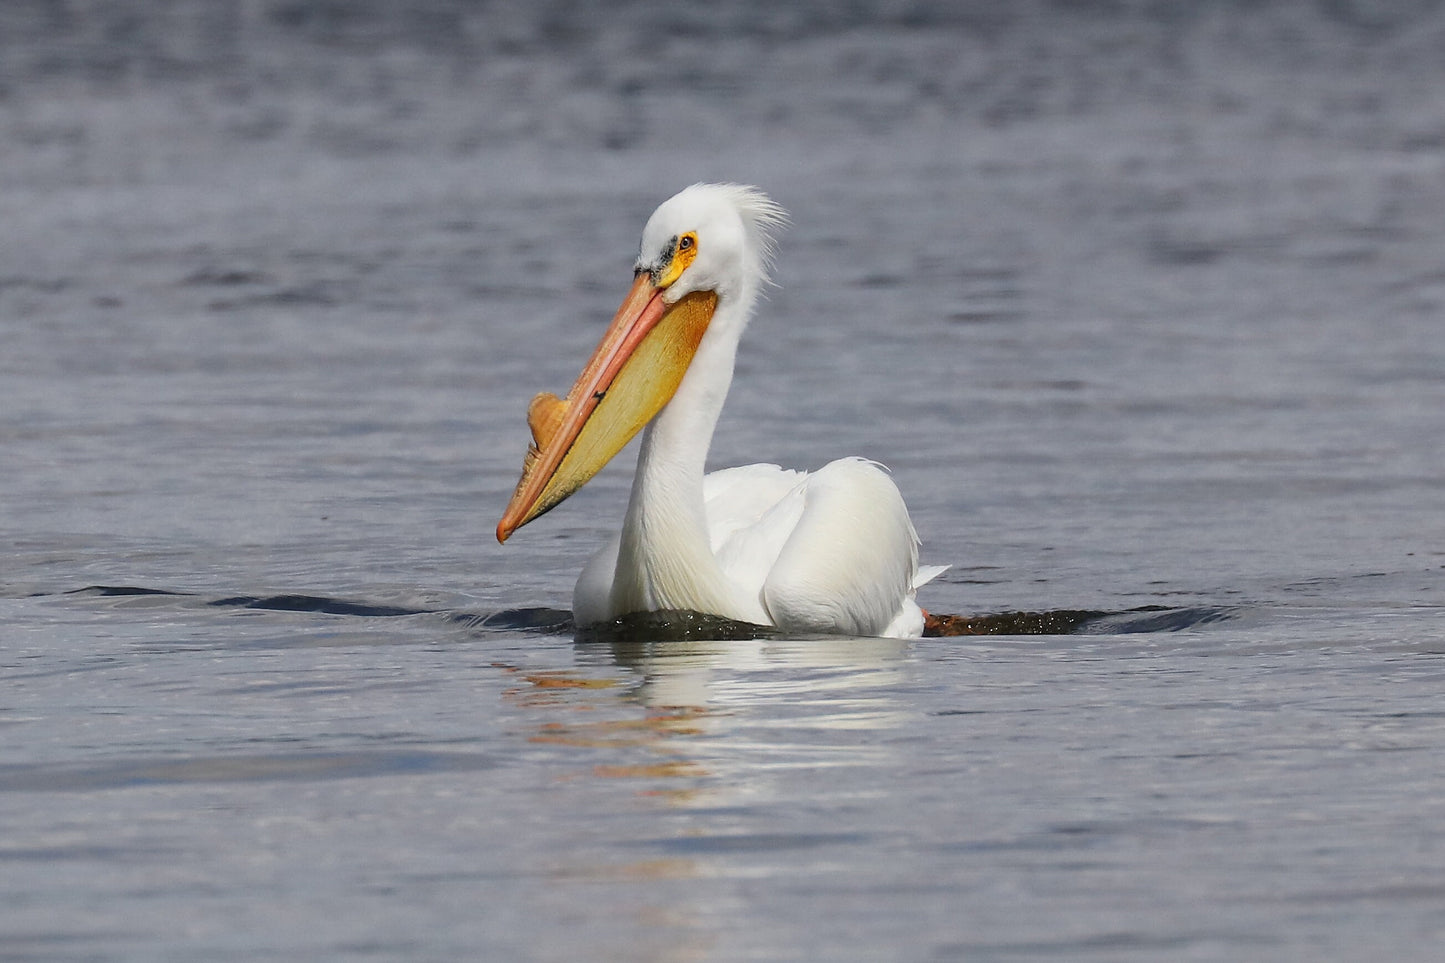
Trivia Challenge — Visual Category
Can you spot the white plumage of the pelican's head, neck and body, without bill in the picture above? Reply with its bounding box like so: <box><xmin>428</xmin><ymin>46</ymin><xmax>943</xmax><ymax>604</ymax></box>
<box><xmin>546</xmin><ymin>184</ymin><xmax>942</xmax><ymax>638</ymax></box>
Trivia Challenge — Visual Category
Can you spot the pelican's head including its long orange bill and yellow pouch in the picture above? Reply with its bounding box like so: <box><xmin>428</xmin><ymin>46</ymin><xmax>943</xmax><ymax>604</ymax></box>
<box><xmin>497</xmin><ymin>184</ymin><xmax>786</xmax><ymax>542</ymax></box>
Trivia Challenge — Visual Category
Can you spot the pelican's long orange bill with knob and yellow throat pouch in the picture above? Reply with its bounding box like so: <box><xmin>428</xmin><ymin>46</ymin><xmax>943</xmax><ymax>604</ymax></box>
<box><xmin>497</xmin><ymin>273</ymin><xmax>717</xmax><ymax>542</ymax></box>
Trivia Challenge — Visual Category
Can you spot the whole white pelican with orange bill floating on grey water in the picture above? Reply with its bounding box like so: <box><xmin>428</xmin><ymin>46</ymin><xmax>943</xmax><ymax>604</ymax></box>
<box><xmin>497</xmin><ymin>184</ymin><xmax>942</xmax><ymax>638</ymax></box>
